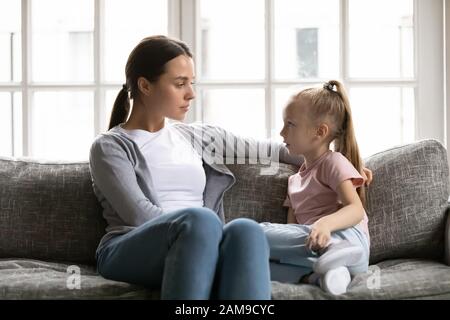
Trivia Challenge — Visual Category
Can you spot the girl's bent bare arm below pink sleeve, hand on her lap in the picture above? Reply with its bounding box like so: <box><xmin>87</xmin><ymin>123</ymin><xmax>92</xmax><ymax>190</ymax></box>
<box><xmin>307</xmin><ymin>180</ymin><xmax>364</xmax><ymax>250</ymax></box>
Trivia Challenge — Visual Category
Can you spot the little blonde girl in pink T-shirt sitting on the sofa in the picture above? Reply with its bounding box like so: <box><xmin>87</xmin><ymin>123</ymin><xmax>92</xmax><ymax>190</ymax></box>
<box><xmin>261</xmin><ymin>80</ymin><xmax>370</xmax><ymax>295</ymax></box>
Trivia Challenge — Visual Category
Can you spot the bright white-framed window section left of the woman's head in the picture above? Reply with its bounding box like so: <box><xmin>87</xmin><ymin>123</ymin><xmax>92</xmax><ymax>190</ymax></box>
<box><xmin>0</xmin><ymin>0</ymin><xmax>169</xmax><ymax>160</ymax></box>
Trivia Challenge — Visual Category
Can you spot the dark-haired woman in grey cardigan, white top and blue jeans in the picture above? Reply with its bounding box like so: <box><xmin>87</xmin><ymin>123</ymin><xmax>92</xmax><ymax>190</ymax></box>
<box><xmin>90</xmin><ymin>36</ymin><xmax>300</xmax><ymax>299</ymax></box>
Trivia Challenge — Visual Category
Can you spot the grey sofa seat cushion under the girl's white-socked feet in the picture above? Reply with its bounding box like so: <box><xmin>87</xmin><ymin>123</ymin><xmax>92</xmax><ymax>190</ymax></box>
<box><xmin>272</xmin><ymin>259</ymin><xmax>450</xmax><ymax>300</ymax></box>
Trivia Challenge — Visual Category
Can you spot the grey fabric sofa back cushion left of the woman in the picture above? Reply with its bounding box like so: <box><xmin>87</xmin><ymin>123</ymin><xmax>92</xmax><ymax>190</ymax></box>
<box><xmin>0</xmin><ymin>158</ymin><xmax>106</xmax><ymax>264</ymax></box>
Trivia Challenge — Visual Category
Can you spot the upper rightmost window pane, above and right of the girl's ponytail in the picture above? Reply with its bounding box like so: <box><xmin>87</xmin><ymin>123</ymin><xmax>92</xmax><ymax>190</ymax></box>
<box><xmin>348</xmin><ymin>0</ymin><xmax>414</xmax><ymax>78</ymax></box>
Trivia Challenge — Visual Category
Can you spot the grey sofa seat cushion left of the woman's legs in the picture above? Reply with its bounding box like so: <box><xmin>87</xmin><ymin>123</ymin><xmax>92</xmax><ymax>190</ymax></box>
<box><xmin>0</xmin><ymin>259</ymin><xmax>159</xmax><ymax>299</ymax></box>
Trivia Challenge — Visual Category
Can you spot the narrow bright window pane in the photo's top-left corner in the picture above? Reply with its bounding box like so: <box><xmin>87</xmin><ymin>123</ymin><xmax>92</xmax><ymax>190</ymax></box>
<box><xmin>0</xmin><ymin>0</ymin><xmax>22</xmax><ymax>82</ymax></box>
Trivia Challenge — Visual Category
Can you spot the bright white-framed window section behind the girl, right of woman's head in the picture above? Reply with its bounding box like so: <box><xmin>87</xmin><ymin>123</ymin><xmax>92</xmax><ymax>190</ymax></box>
<box><xmin>185</xmin><ymin>0</ymin><xmax>444</xmax><ymax>157</ymax></box>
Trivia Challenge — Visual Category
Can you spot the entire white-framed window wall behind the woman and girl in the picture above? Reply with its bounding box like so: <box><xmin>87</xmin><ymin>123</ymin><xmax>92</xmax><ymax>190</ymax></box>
<box><xmin>0</xmin><ymin>0</ymin><xmax>446</xmax><ymax>159</ymax></box>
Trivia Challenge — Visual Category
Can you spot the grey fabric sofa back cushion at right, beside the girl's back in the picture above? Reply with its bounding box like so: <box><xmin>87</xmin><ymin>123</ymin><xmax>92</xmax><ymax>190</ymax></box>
<box><xmin>365</xmin><ymin>140</ymin><xmax>449</xmax><ymax>263</ymax></box>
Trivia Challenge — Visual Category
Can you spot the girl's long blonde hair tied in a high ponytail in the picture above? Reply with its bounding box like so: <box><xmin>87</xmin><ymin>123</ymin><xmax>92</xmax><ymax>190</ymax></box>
<box><xmin>294</xmin><ymin>80</ymin><xmax>365</xmax><ymax>205</ymax></box>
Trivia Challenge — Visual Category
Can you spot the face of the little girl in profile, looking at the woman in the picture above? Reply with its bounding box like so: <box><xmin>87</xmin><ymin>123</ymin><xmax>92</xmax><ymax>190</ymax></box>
<box><xmin>280</xmin><ymin>98</ymin><xmax>317</xmax><ymax>155</ymax></box>
